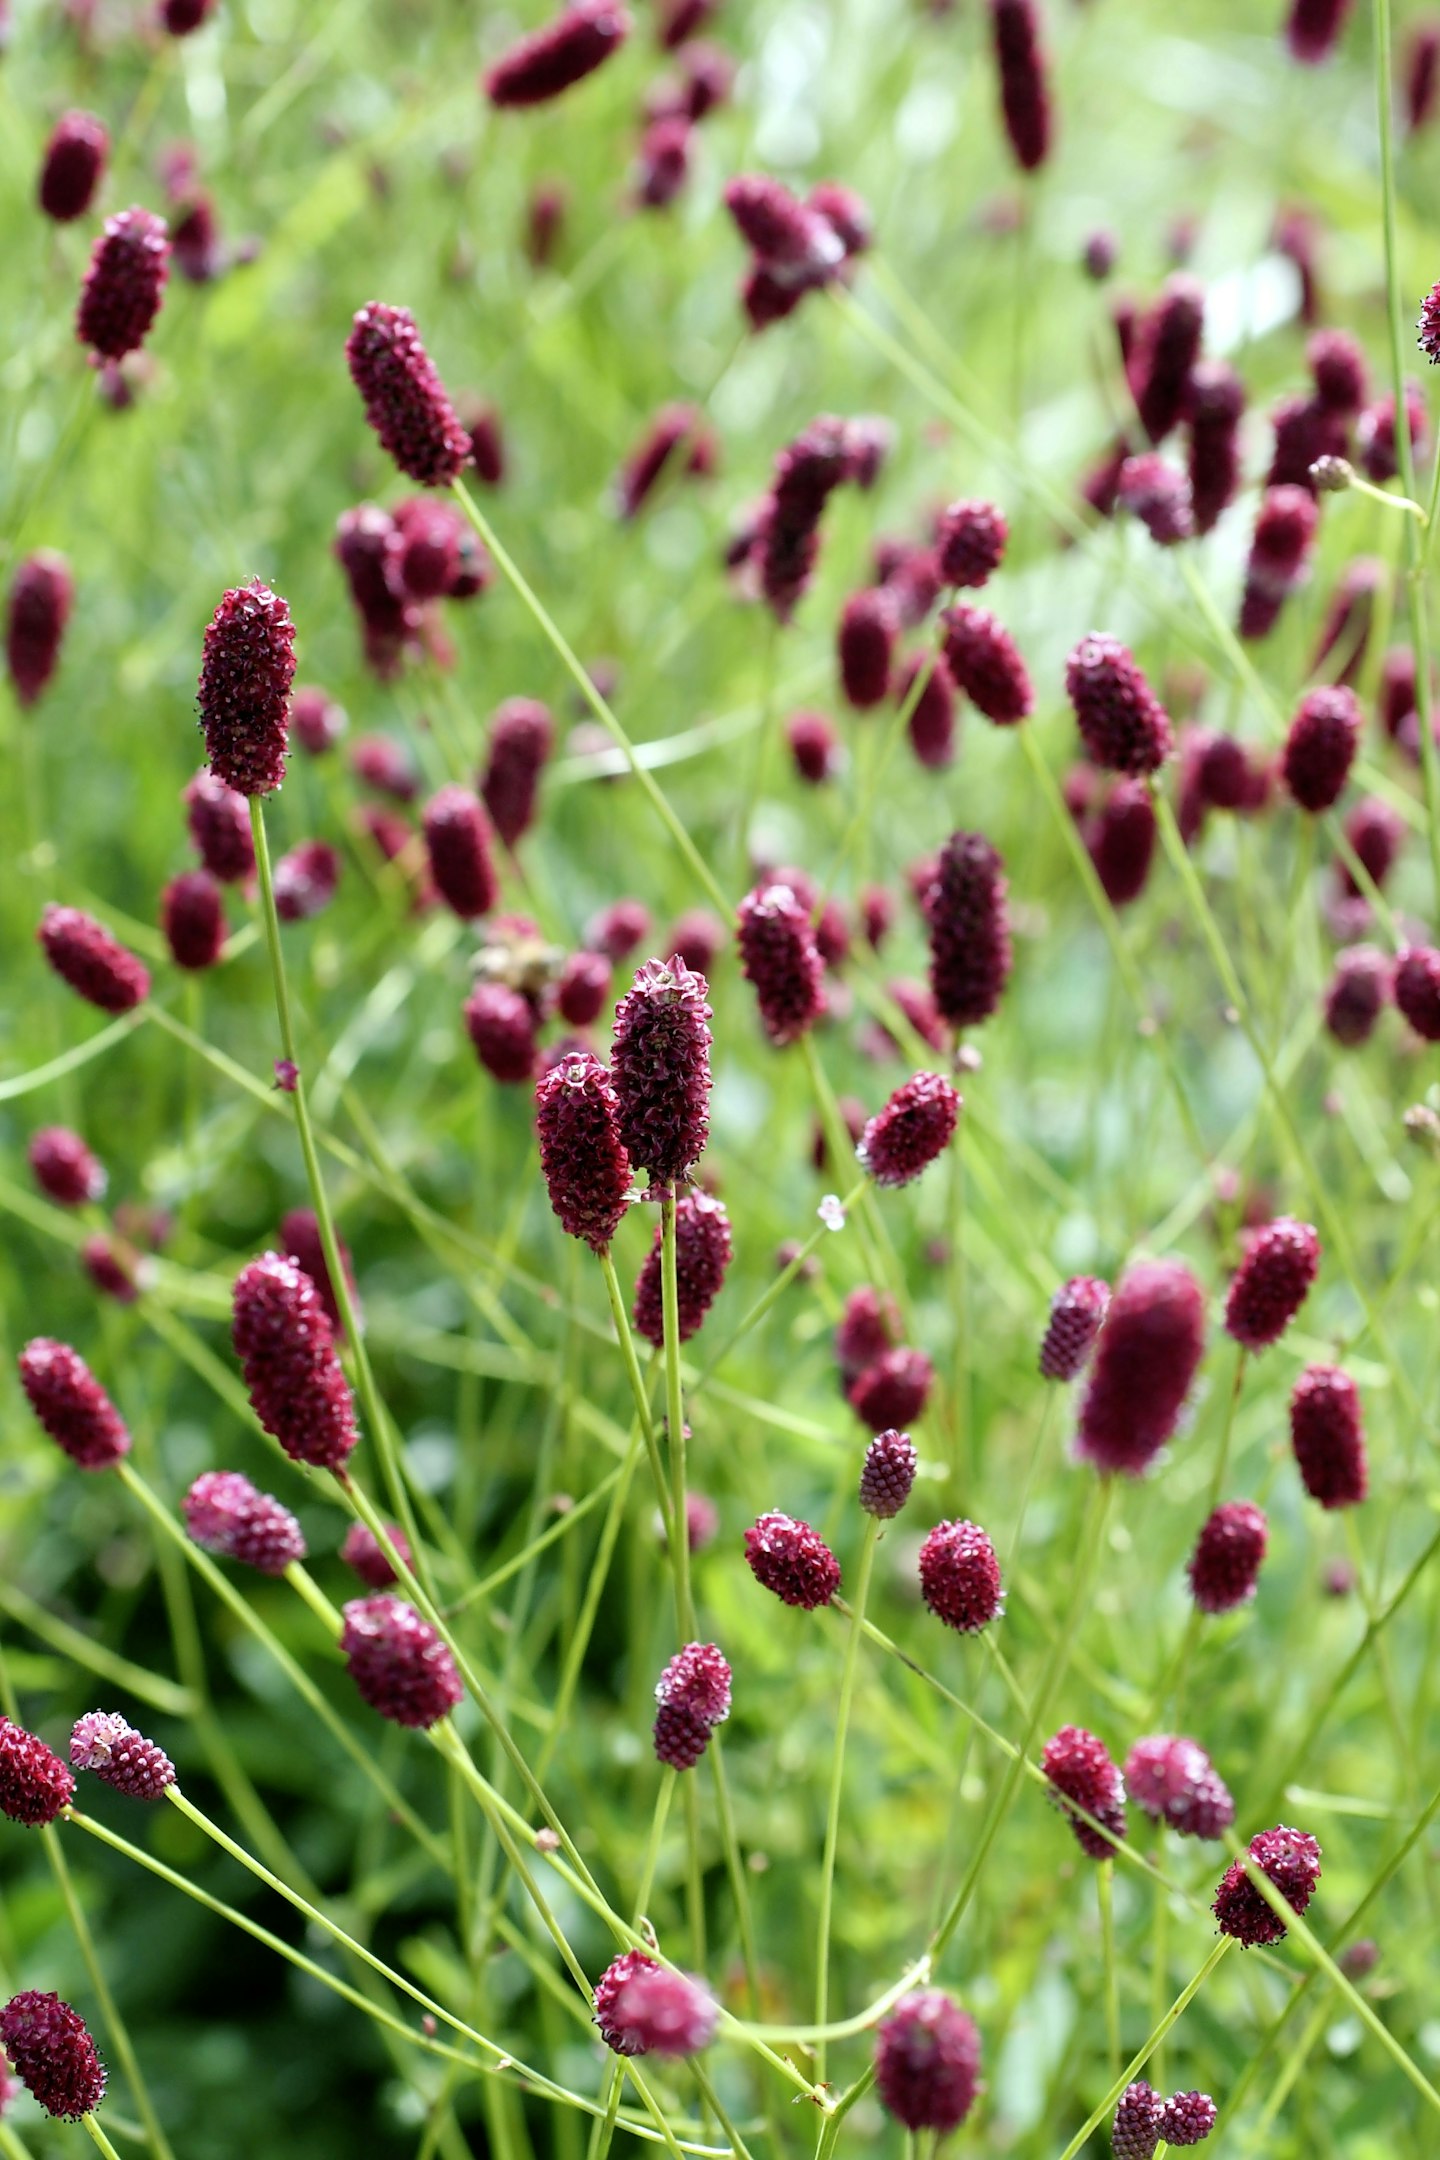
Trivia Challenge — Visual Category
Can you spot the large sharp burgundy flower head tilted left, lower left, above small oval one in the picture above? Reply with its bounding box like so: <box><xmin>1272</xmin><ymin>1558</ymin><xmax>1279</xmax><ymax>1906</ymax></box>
<box><xmin>231</xmin><ymin>1253</ymin><xmax>358</xmax><ymax>1471</ymax></box>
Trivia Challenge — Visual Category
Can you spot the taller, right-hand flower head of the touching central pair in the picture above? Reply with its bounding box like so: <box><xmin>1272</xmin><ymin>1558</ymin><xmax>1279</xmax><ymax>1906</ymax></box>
<box><xmin>611</xmin><ymin>957</ymin><xmax>710</xmax><ymax>1184</ymax></box>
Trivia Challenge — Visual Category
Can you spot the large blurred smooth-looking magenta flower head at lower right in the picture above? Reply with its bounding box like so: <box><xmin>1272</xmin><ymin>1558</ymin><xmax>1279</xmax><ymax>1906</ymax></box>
<box><xmin>1075</xmin><ymin>1259</ymin><xmax>1205</xmax><ymax>1477</ymax></box>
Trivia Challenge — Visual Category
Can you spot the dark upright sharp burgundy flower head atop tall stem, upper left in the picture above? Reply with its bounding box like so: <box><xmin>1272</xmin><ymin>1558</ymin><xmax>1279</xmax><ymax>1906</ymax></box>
<box><xmin>196</xmin><ymin>579</ymin><xmax>296</xmax><ymax>795</ymax></box>
